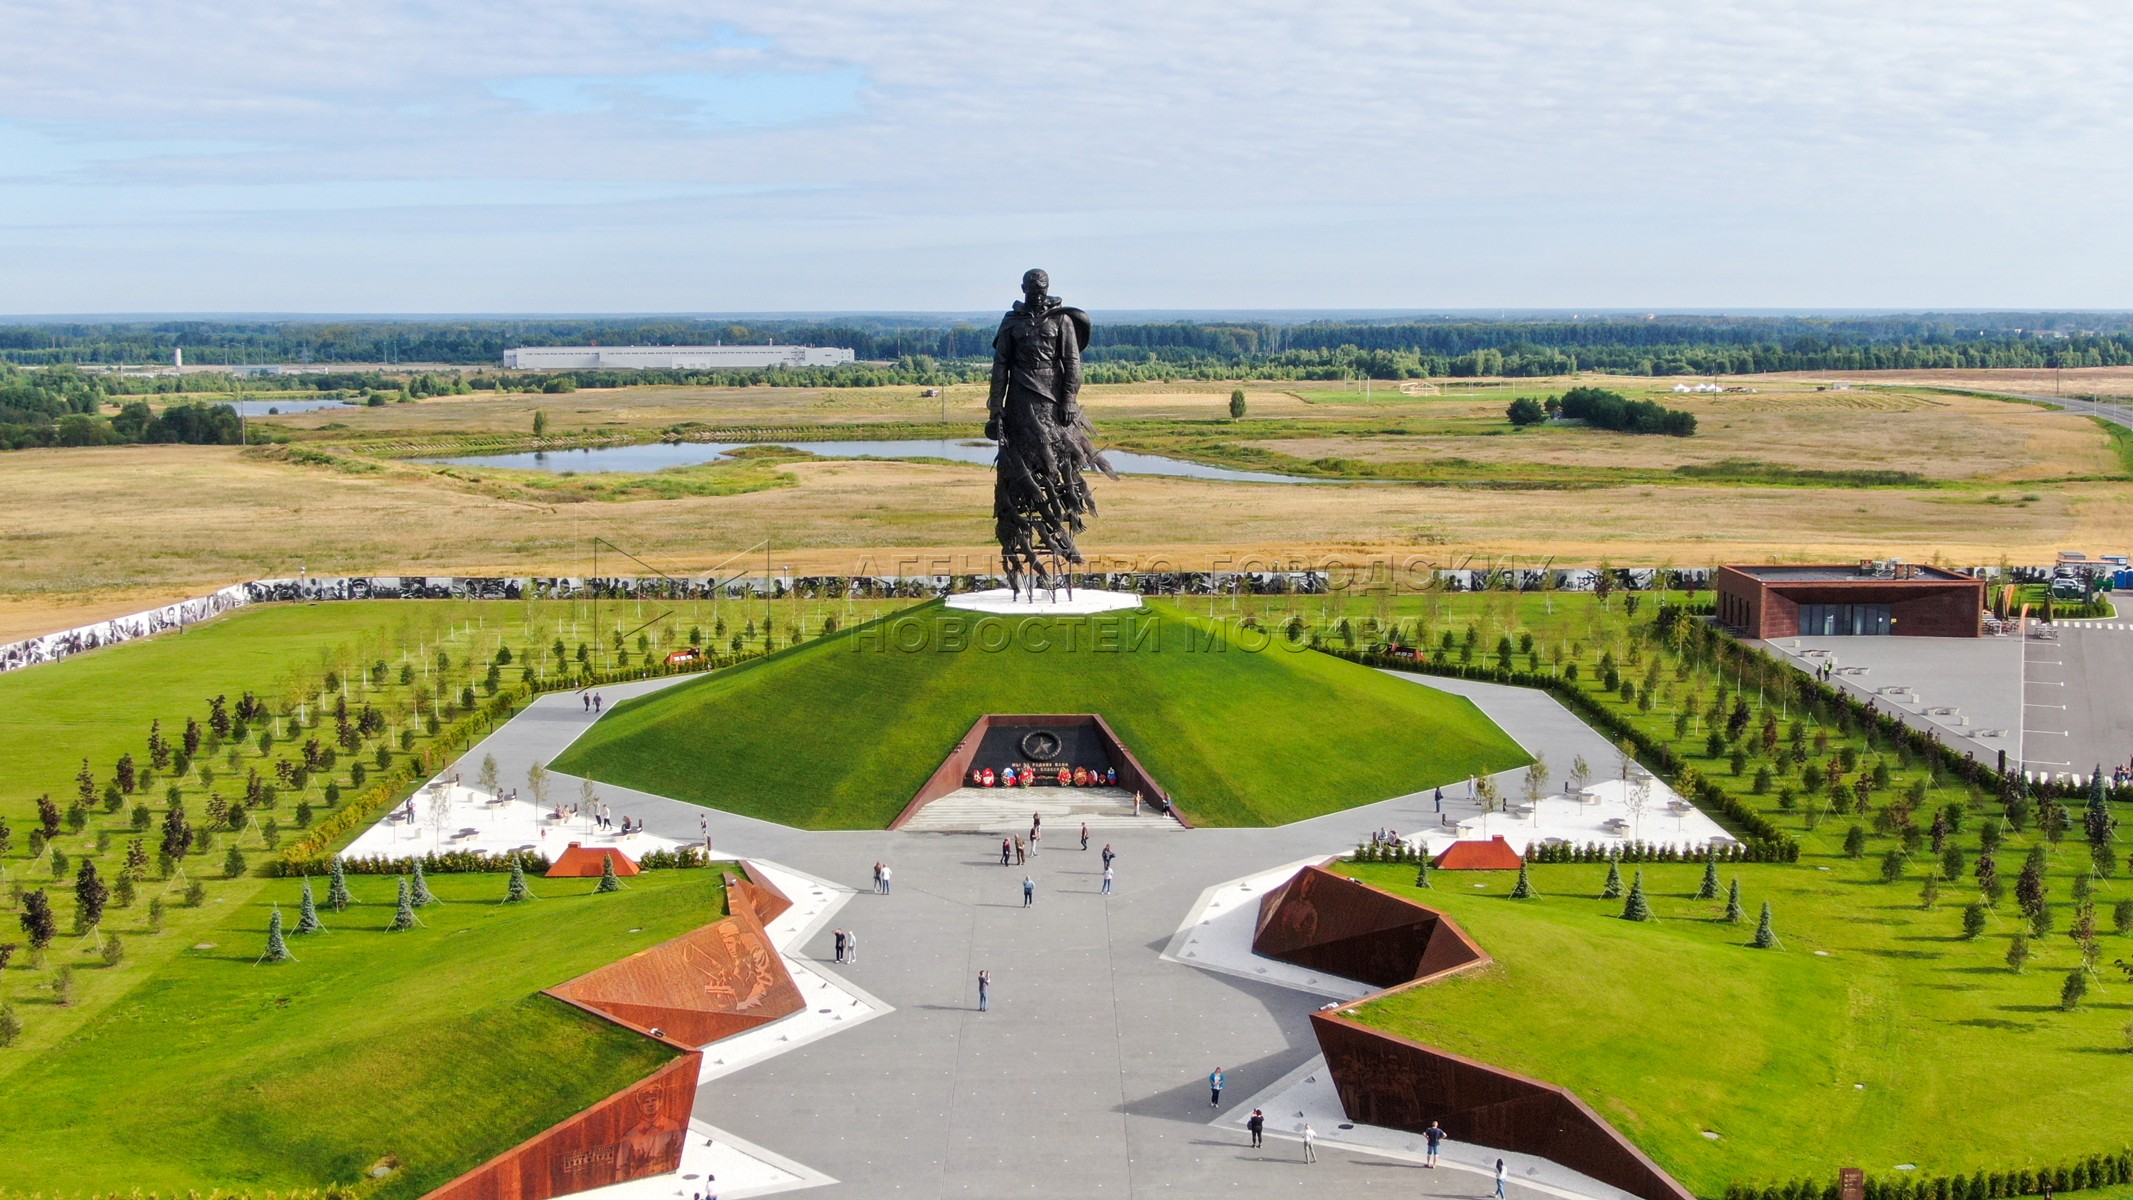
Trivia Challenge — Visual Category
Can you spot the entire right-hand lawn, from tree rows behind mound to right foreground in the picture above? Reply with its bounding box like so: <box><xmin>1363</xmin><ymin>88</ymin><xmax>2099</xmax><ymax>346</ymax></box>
<box><xmin>1261</xmin><ymin>593</ymin><xmax>2133</xmax><ymax>1196</ymax></box>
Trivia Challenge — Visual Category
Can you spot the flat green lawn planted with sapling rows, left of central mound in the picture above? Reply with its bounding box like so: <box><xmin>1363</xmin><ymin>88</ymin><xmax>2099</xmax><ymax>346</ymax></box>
<box><xmin>0</xmin><ymin>601</ymin><xmax>881</xmax><ymax>1089</ymax></box>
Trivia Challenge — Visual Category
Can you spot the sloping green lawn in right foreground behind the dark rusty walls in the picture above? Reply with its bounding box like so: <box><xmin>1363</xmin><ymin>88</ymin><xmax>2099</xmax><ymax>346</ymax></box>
<box><xmin>1342</xmin><ymin>861</ymin><xmax>2133</xmax><ymax>1196</ymax></box>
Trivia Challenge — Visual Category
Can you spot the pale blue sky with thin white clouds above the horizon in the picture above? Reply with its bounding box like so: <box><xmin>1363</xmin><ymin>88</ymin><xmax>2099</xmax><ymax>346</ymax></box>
<box><xmin>0</xmin><ymin>0</ymin><xmax>2133</xmax><ymax>313</ymax></box>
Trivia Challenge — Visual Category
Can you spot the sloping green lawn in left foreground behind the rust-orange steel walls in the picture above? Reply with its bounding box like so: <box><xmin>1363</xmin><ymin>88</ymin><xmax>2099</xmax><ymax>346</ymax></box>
<box><xmin>0</xmin><ymin>870</ymin><xmax>723</xmax><ymax>1200</ymax></box>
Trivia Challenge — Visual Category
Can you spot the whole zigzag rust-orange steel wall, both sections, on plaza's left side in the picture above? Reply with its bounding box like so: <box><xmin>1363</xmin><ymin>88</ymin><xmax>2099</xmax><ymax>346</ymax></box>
<box><xmin>422</xmin><ymin>863</ymin><xmax>806</xmax><ymax>1200</ymax></box>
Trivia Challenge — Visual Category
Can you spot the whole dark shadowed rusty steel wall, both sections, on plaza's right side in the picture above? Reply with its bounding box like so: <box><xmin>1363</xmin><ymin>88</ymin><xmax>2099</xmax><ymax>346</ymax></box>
<box><xmin>1252</xmin><ymin>867</ymin><xmax>1694</xmax><ymax>1200</ymax></box>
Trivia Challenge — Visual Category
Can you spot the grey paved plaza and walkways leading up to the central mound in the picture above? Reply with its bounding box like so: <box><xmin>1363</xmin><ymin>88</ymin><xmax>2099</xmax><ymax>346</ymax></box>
<box><xmin>441</xmin><ymin>680</ymin><xmax>1689</xmax><ymax>1200</ymax></box>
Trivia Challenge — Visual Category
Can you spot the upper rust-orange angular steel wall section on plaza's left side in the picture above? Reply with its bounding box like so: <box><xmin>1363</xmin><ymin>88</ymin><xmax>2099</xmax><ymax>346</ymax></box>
<box><xmin>548</xmin><ymin>876</ymin><xmax>806</xmax><ymax>1047</ymax></box>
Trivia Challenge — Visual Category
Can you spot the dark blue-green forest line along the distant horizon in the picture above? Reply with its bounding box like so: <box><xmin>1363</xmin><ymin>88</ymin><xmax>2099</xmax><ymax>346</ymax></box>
<box><xmin>0</xmin><ymin>313</ymin><xmax>2133</xmax><ymax>386</ymax></box>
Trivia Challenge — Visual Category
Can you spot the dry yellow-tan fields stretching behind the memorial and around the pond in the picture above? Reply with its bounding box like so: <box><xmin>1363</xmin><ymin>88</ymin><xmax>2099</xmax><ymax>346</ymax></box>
<box><xmin>0</xmin><ymin>377</ymin><xmax>2133</xmax><ymax>637</ymax></box>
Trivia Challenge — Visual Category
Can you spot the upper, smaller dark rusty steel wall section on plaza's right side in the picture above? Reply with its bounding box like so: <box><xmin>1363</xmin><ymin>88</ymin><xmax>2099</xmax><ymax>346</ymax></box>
<box><xmin>1252</xmin><ymin>867</ymin><xmax>1489</xmax><ymax>987</ymax></box>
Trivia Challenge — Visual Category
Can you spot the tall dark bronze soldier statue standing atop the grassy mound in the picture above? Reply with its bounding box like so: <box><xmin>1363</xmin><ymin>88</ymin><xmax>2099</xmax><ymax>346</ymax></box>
<box><xmin>985</xmin><ymin>271</ymin><xmax>1118</xmax><ymax>599</ymax></box>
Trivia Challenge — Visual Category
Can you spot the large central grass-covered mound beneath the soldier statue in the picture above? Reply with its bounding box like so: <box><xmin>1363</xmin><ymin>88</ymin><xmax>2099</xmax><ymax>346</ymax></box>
<box><xmin>555</xmin><ymin>605</ymin><xmax>1525</xmax><ymax>829</ymax></box>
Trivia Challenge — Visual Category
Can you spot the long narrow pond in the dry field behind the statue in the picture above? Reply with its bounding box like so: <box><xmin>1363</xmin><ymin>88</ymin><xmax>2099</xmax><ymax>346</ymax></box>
<box><xmin>420</xmin><ymin>437</ymin><xmax>1340</xmax><ymax>484</ymax></box>
